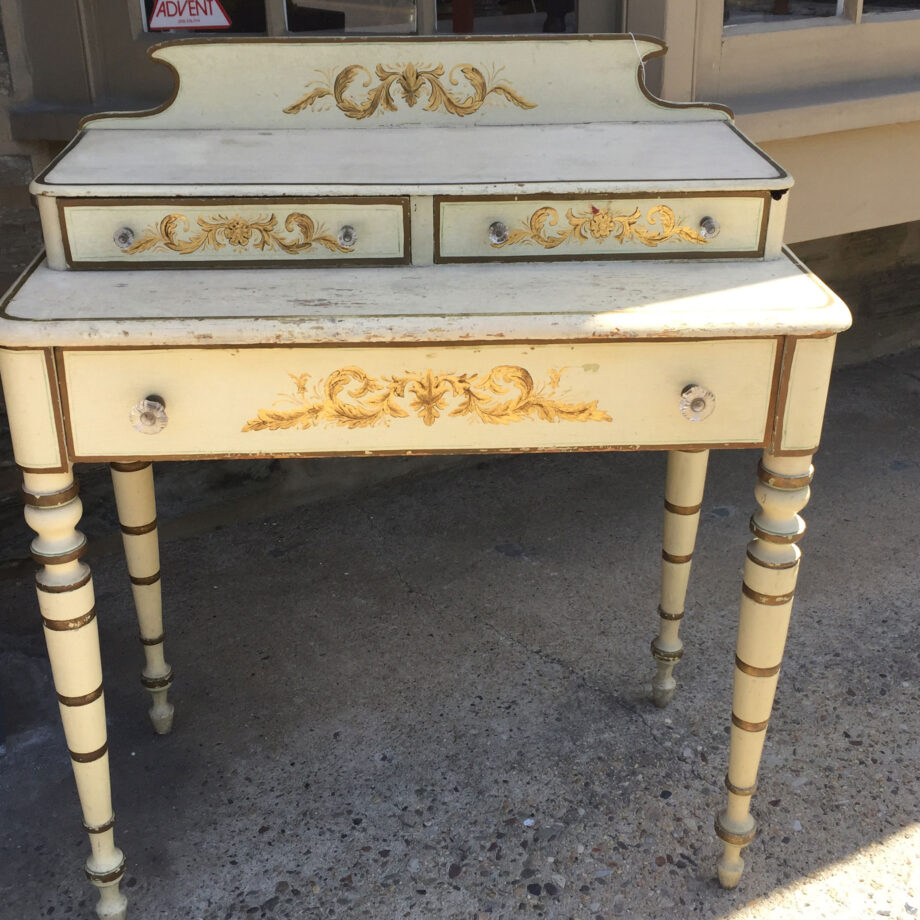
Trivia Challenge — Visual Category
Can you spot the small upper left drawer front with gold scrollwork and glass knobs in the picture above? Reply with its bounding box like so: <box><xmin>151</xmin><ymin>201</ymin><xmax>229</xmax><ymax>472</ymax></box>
<box><xmin>59</xmin><ymin>198</ymin><xmax>409</xmax><ymax>268</ymax></box>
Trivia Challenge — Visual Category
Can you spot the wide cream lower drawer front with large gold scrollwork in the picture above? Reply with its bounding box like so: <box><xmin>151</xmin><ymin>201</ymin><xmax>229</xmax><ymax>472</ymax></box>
<box><xmin>61</xmin><ymin>339</ymin><xmax>778</xmax><ymax>460</ymax></box>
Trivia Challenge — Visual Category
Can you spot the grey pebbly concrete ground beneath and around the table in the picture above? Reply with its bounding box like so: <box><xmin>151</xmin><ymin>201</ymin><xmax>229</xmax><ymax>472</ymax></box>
<box><xmin>0</xmin><ymin>351</ymin><xmax>920</xmax><ymax>920</ymax></box>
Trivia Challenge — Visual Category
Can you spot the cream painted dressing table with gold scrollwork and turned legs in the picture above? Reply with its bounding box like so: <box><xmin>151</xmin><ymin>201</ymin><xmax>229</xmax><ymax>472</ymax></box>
<box><xmin>0</xmin><ymin>36</ymin><xmax>849</xmax><ymax>918</ymax></box>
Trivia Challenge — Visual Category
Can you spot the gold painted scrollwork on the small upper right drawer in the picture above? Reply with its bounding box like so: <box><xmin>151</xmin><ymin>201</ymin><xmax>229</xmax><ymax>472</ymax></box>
<box><xmin>492</xmin><ymin>204</ymin><xmax>709</xmax><ymax>249</ymax></box>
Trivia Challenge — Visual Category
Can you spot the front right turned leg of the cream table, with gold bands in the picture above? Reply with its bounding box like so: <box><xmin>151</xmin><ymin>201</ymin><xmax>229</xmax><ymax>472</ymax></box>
<box><xmin>716</xmin><ymin>451</ymin><xmax>813</xmax><ymax>888</ymax></box>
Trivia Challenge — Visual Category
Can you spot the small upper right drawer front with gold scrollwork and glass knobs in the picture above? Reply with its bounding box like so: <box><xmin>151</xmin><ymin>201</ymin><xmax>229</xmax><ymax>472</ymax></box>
<box><xmin>434</xmin><ymin>192</ymin><xmax>769</xmax><ymax>262</ymax></box>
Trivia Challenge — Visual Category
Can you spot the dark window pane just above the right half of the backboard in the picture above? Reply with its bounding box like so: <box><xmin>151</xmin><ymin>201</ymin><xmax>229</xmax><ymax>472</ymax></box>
<box><xmin>438</xmin><ymin>0</ymin><xmax>575</xmax><ymax>35</ymax></box>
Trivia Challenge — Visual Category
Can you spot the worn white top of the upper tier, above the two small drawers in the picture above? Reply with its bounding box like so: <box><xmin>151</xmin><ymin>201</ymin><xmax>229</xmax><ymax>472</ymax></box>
<box><xmin>30</xmin><ymin>122</ymin><xmax>791</xmax><ymax>198</ymax></box>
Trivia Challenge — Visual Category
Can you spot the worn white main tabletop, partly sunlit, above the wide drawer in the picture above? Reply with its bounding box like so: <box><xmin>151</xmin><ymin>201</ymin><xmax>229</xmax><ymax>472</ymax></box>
<box><xmin>0</xmin><ymin>253</ymin><xmax>850</xmax><ymax>348</ymax></box>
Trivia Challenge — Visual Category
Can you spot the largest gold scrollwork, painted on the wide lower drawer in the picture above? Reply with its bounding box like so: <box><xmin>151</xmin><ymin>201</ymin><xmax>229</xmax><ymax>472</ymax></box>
<box><xmin>243</xmin><ymin>365</ymin><xmax>611</xmax><ymax>431</ymax></box>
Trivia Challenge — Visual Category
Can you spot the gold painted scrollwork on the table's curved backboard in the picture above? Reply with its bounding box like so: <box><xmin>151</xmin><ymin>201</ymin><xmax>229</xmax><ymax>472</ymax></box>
<box><xmin>284</xmin><ymin>64</ymin><xmax>536</xmax><ymax>119</ymax></box>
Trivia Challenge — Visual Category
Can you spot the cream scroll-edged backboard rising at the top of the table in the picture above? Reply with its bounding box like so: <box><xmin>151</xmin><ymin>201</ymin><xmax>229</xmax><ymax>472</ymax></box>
<box><xmin>82</xmin><ymin>35</ymin><xmax>728</xmax><ymax>130</ymax></box>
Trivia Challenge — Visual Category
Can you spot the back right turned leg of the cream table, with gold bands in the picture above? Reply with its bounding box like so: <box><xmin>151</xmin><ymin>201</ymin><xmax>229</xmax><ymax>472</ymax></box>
<box><xmin>652</xmin><ymin>450</ymin><xmax>709</xmax><ymax>706</ymax></box>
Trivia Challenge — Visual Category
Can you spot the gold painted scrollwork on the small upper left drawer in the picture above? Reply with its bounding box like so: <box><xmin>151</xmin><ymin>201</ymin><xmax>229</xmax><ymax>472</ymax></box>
<box><xmin>125</xmin><ymin>212</ymin><xmax>353</xmax><ymax>256</ymax></box>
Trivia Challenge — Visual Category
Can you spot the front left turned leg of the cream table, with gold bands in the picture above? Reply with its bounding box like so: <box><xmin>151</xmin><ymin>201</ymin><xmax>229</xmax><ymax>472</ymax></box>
<box><xmin>23</xmin><ymin>472</ymin><xmax>127</xmax><ymax>920</ymax></box>
